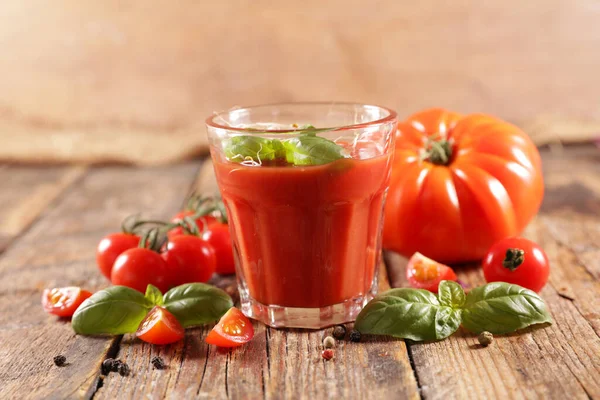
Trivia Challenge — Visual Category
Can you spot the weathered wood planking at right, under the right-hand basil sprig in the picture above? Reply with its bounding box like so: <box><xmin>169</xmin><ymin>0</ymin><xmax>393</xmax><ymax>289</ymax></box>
<box><xmin>388</xmin><ymin>148</ymin><xmax>600</xmax><ymax>399</ymax></box>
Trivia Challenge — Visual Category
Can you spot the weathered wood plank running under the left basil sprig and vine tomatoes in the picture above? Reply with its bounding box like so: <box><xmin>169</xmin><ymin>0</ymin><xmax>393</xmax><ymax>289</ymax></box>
<box><xmin>0</xmin><ymin>163</ymin><xmax>198</xmax><ymax>398</ymax></box>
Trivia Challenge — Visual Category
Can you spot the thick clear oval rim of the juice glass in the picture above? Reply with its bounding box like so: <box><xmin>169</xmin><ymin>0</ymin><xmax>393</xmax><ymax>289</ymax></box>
<box><xmin>205</xmin><ymin>101</ymin><xmax>398</xmax><ymax>134</ymax></box>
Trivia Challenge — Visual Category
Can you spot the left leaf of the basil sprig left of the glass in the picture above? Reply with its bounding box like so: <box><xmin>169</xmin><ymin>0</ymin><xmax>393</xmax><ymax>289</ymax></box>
<box><xmin>71</xmin><ymin>286</ymin><xmax>154</xmax><ymax>335</ymax></box>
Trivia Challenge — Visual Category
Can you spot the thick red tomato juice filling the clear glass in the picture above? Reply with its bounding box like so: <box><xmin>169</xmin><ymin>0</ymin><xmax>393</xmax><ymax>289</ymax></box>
<box><xmin>214</xmin><ymin>154</ymin><xmax>390</xmax><ymax>308</ymax></box>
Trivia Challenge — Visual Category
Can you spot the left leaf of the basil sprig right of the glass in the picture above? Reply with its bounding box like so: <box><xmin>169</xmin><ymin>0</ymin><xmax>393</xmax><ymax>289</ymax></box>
<box><xmin>354</xmin><ymin>288</ymin><xmax>461</xmax><ymax>341</ymax></box>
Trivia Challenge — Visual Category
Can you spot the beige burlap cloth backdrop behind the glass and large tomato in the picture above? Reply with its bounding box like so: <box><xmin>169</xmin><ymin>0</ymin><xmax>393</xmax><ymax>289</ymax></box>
<box><xmin>0</xmin><ymin>0</ymin><xmax>600</xmax><ymax>164</ymax></box>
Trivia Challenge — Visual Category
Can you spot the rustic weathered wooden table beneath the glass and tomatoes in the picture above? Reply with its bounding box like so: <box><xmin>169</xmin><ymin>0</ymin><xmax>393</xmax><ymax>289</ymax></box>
<box><xmin>0</xmin><ymin>146</ymin><xmax>600</xmax><ymax>399</ymax></box>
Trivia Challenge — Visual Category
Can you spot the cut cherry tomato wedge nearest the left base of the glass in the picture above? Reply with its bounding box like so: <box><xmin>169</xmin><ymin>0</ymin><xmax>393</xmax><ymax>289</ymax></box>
<box><xmin>206</xmin><ymin>307</ymin><xmax>254</xmax><ymax>347</ymax></box>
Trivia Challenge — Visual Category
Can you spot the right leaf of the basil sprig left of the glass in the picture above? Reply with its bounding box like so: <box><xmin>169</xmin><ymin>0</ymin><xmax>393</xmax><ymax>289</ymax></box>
<box><xmin>164</xmin><ymin>283</ymin><xmax>233</xmax><ymax>328</ymax></box>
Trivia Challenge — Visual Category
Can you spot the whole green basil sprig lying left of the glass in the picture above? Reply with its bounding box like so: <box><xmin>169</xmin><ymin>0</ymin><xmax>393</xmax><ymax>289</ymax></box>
<box><xmin>72</xmin><ymin>283</ymin><xmax>233</xmax><ymax>335</ymax></box>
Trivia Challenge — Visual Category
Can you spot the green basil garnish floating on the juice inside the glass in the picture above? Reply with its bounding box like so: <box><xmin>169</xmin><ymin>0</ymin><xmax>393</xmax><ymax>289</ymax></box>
<box><xmin>223</xmin><ymin>125</ymin><xmax>348</xmax><ymax>166</ymax></box>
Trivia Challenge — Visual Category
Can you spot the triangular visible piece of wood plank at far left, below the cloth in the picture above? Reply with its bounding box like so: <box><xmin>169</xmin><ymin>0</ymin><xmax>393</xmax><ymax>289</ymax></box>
<box><xmin>0</xmin><ymin>165</ymin><xmax>85</xmax><ymax>253</ymax></box>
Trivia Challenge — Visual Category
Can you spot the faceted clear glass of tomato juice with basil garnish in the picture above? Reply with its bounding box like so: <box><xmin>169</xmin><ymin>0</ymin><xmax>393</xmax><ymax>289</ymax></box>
<box><xmin>206</xmin><ymin>103</ymin><xmax>397</xmax><ymax>329</ymax></box>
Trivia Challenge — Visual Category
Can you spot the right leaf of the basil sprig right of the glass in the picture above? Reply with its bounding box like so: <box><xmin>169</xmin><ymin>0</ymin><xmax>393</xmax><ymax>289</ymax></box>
<box><xmin>462</xmin><ymin>282</ymin><xmax>552</xmax><ymax>334</ymax></box>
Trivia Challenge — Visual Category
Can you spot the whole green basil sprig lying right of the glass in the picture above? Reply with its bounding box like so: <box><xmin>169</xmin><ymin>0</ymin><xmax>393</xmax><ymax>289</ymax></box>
<box><xmin>355</xmin><ymin>281</ymin><xmax>552</xmax><ymax>341</ymax></box>
